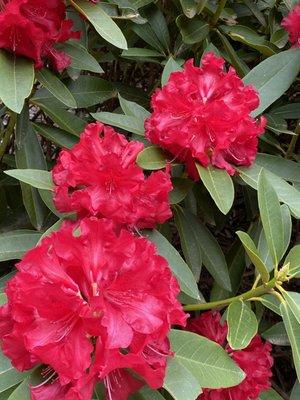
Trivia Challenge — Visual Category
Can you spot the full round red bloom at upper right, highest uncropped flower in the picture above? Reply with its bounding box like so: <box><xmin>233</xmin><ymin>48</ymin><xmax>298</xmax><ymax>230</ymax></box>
<box><xmin>145</xmin><ymin>53</ymin><xmax>266</xmax><ymax>180</ymax></box>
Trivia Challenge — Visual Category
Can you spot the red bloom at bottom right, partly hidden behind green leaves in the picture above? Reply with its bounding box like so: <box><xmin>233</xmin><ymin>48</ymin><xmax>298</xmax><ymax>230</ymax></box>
<box><xmin>186</xmin><ymin>311</ymin><xmax>273</xmax><ymax>400</ymax></box>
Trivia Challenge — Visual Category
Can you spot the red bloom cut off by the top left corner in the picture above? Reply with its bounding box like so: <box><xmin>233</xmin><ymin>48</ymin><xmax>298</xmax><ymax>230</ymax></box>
<box><xmin>0</xmin><ymin>0</ymin><xmax>80</xmax><ymax>71</ymax></box>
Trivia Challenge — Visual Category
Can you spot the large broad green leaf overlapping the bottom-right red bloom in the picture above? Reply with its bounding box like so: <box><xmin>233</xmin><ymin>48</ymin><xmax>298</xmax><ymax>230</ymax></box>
<box><xmin>169</xmin><ymin>329</ymin><xmax>245</xmax><ymax>389</ymax></box>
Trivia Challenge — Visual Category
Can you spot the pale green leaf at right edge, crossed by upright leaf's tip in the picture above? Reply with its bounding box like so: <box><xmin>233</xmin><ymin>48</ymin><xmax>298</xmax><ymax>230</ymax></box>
<box><xmin>237</xmin><ymin>164</ymin><xmax>300</xmax><ymax>218</ymax></box>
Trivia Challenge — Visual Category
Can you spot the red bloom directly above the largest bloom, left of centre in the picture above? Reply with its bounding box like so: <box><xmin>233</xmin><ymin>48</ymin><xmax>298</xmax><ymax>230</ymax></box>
<box><xmin>52</xmin><ymin>123</ymin><xmax>172</xmax><ymax>228</ymax></box>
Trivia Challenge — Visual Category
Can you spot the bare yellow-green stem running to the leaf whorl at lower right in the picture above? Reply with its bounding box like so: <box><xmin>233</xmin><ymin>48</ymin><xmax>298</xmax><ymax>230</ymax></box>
<box><xmin>183</xmin><ymin>278</ymin><xmax>278</xmax><ymax>311</ymax></box>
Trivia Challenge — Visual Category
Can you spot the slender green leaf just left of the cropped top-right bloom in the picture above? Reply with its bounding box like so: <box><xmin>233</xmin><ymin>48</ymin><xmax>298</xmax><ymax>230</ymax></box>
<box><xmin>220</xmin><ymin>25</ymin><xmax>278</xmax><ymax>56</ymax></box>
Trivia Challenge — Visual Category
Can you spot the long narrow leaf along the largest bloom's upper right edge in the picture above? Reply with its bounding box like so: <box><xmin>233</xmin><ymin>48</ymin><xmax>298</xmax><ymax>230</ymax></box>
<box><xmin>143</xmin><ymin>229</ymin><xmax>200</xmax><ymax>299</ymax></box>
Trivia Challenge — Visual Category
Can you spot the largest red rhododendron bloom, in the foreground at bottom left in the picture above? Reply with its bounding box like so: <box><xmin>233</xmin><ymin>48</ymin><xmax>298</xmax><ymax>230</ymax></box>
<box><xmin>0</xmin><ymin>217</ymin><xmax>186</xmax><ymax>400</ymax></box>
